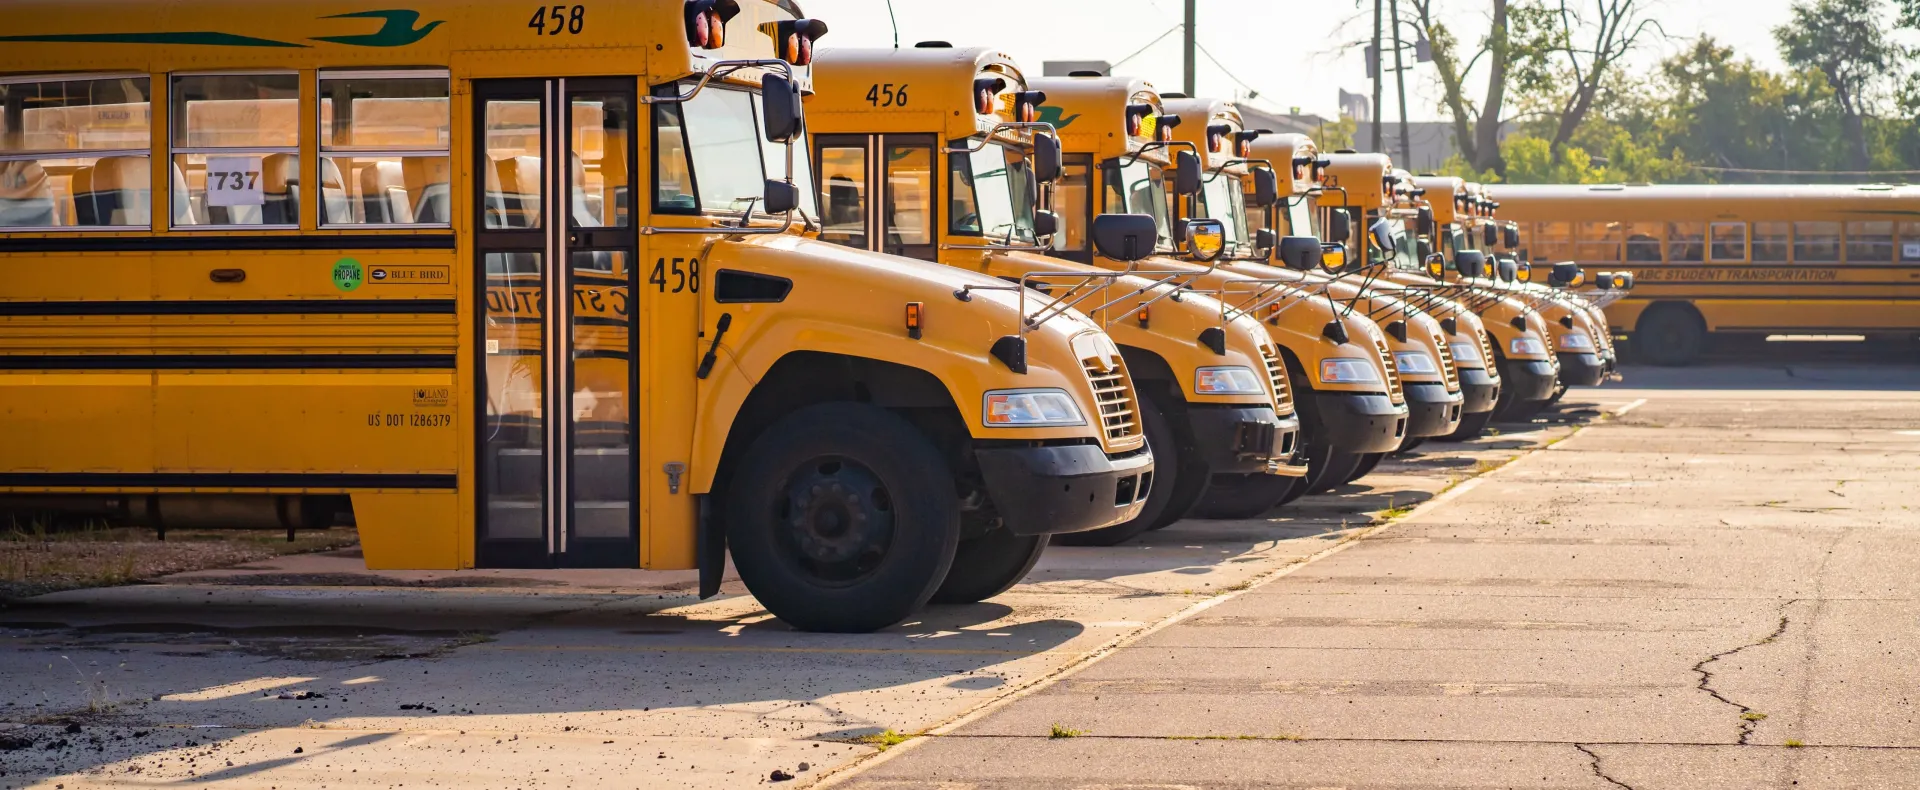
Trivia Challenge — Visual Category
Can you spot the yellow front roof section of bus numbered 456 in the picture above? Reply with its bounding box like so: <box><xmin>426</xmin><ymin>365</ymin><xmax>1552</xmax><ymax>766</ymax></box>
<box><xmin>806</xmin><ymin>46</ymin><xmax>1029</xmax><ymax>140</ymax></box>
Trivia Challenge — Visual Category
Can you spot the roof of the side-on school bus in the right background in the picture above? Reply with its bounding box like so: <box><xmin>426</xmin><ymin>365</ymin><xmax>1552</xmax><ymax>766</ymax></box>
<box><xmin>1486</xmin><ymin>185</ymin><xmax>1920</xmax><ymax>221</ymax></box>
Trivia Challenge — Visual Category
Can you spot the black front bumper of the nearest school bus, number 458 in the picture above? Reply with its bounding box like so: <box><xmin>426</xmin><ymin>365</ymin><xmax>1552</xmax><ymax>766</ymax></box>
<box><xmin>973</xmin><ymin>444</ymin><xmax>1154</xmax><ymax>534</ymax></box>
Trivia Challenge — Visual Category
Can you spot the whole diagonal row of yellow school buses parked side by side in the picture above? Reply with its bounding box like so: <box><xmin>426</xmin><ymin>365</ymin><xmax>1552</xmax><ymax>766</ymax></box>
<box><xmin>0</xmin><ymin>0</ymin><xmax>1632</xmax><ymax>630</ymax></box>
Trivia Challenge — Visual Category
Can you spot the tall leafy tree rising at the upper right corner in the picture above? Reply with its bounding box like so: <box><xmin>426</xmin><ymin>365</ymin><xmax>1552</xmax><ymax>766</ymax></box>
<box><xmin>1774</xmin><ymin>0</ymin><xmax>1910</xmax><ymax>171</ymax></box>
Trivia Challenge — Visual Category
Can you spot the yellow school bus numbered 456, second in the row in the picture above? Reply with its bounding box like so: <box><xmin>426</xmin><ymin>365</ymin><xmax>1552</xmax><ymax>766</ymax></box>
<box><xmin>806</xmin><ymin>42</ymin><xmax>1306</xmax><ymax>546</ymax></box>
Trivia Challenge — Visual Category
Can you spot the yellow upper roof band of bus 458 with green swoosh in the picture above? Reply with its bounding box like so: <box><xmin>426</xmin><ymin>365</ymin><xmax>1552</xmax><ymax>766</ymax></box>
<box><xmin>0</xmin><ymin>0</ymin><xmax>804</xmax><ymax>83</ymax></box>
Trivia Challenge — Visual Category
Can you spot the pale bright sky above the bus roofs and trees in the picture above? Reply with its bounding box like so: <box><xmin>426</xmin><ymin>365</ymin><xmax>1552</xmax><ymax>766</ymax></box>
<box><xmin>797</xmin><ymin>0</ymin><xmax>1789</xmax><ymax>121</ymax></box>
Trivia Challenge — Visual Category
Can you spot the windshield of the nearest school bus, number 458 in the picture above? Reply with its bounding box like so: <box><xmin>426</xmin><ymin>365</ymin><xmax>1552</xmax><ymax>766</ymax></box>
<box><xmin>653</xmin><ymin>85</ymin><xmax>818</xmax><ymax>217</ymax></box>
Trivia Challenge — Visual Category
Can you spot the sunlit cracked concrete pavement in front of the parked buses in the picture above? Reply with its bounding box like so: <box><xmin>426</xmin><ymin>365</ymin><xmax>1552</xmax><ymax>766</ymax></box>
<box><xmin>839</xmin><ymin>390</ymin><xmax>1920</xmax><ymax>790</ymax></box>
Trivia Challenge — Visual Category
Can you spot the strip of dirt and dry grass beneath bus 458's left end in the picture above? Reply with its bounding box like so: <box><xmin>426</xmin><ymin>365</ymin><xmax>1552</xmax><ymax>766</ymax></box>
<box><xmin>0</xmin><ymin>525</ymin><xmax>359</xmax><ymax>602</ymax></box>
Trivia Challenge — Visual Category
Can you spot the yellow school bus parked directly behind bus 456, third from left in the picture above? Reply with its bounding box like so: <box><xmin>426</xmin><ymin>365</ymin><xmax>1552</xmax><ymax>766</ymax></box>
<box><xmin>1029</xmin><ymin>75</ymin><xmax>1407</xmax><ymax>517</ymax></box>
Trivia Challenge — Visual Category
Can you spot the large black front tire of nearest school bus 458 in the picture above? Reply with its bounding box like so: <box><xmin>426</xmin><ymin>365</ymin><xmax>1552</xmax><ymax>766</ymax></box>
<box><xmin>720</xmin><ymin>404</ymin><xmax>960</xmax><ymax>632</ymax></box>
